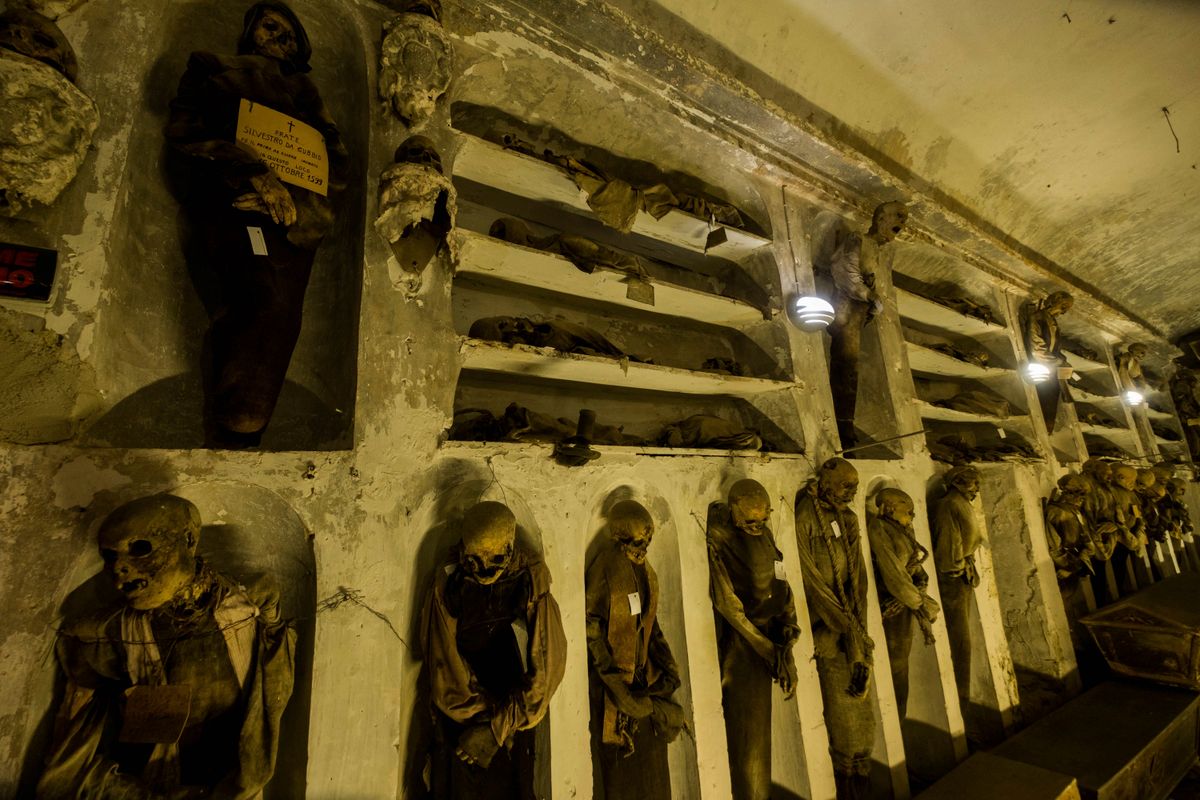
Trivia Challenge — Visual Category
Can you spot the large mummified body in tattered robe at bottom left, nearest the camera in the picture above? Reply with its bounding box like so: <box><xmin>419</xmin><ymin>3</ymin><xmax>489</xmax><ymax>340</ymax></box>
<box><xmin>38</xmin><ymin>494</ymin><xmax>295</xmax><ymax>800</ymax></box>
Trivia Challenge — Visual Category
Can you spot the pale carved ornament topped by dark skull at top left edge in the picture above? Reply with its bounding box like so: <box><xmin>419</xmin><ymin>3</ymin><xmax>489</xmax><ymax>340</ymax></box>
<box><xmin>0</xmin><ymin>10</ymin><xmax>100</xmax><ymax>215</ymax></box>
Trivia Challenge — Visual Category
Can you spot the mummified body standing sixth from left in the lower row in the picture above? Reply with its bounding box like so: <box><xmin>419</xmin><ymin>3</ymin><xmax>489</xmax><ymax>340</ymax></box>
<box><xmin>866</xmin><ymin>489</ymin><xmax>941</xmax><ymax>720</ymax></box>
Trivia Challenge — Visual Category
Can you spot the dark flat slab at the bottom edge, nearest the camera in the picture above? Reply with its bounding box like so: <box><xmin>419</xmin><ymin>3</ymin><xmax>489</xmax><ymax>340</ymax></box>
<box><xmin>917</xmin><ymin>753</ymin><xmax>1080</xmax><ymax>800</ymax></box>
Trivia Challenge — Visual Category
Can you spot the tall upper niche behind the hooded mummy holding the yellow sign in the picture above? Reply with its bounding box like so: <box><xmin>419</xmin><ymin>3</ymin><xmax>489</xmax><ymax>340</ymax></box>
<box><xmin>83</xmin><ymin>0</ymin><xmax>371</xmax><ymax>450</ymax></box>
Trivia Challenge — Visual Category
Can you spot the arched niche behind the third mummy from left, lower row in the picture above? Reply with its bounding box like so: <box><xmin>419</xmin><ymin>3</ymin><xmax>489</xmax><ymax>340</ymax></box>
<box><xmin>570</xmin><ymin>483</ymin><xmax>700</xmax><ymax>799</ymax></box>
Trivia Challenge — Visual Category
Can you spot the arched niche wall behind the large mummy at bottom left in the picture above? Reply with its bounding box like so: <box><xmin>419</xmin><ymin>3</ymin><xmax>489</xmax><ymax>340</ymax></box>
<box><xmin>22</xmin><ymin>482</ymin><xmax>317</xmax><ymax>800</ymax></box>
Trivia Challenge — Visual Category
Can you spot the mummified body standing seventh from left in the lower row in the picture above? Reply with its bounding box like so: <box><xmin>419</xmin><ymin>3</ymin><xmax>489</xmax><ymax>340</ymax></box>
<box><xmin>930</xmin><ymin>467</ymin><xmax>983</xmax><ymax>699</ymax></box>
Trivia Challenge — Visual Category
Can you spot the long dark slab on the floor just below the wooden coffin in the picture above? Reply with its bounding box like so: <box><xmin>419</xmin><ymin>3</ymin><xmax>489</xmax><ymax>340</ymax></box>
<box><xmin>991</xmin><ymin>681</ymin><xmax>1200</xmax><ymax>800</ymax></box>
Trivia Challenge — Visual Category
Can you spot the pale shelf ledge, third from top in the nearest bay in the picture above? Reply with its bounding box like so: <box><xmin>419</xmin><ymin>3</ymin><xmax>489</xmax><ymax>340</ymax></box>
<box><xmin>458</xmin><ymin>337</ymin><xmax>800</xmax><ymax>398</ymax></box>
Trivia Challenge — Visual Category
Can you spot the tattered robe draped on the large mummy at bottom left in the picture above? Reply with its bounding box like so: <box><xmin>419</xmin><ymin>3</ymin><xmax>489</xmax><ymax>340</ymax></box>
<box><xmin>37</xmin><ymin>573</ymin><xmax>296</xmax><ymax>800</ymax></box>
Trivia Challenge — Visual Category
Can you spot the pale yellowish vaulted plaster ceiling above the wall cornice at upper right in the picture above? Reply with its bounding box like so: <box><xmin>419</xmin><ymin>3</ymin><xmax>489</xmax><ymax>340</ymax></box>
<box><xmin>656</xmin><ymin>0</ymin><xmax>1200</xmax><ymax>337</ymax></box>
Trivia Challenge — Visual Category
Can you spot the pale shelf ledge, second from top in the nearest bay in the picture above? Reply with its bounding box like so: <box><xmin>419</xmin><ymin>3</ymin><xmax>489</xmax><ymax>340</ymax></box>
<box><xmin>455</xmin><ymin>229</ymin><xmax>763</xmax><ymax>329</ymax></box>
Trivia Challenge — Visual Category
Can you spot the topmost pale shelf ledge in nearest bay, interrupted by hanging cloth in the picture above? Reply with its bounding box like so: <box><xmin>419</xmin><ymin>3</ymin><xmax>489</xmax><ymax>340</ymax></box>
<box><xmin>454</xmin><ymin>133</ymin><xmax>770</xmax><ymax>261</ymax></box>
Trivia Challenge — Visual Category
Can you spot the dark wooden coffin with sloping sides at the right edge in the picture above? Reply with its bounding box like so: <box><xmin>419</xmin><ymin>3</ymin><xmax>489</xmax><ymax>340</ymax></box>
<box><xmin>1080</xmin><ymin>572</ymin><xmax>1200</xmax><ymax>691</ymax></box>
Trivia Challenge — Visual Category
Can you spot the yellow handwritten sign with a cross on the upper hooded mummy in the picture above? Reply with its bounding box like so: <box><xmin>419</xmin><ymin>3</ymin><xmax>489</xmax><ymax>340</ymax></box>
<box><xmin>238</xmin><ymin>98</ymin><xmax>329</xmax><ymax>194</ymax></box>
